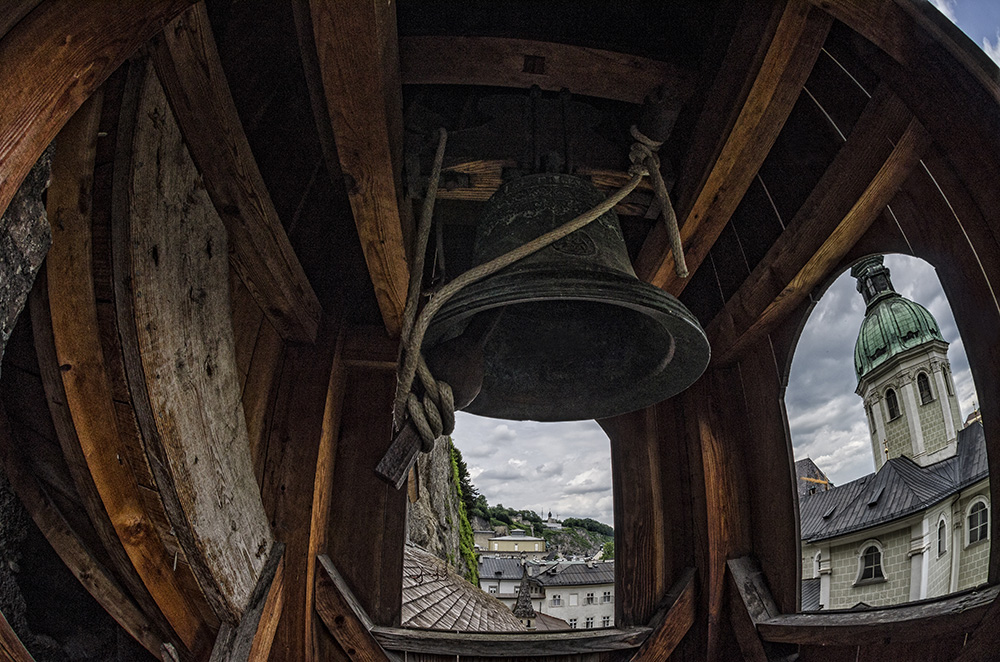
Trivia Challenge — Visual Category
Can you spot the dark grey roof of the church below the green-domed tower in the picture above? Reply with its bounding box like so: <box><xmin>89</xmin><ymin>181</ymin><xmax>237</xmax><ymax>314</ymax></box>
<box><xmin>799</xmin><ymin>423</ymin><xmax>988</xmax><ymax>542</ymax></box>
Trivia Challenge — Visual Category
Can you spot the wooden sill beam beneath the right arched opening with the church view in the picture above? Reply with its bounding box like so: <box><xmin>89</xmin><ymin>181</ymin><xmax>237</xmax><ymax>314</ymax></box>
<box><xmin>756</xmin><ymin>586</ymin><xmax>1000</xmax><ymax>648</ymax></box>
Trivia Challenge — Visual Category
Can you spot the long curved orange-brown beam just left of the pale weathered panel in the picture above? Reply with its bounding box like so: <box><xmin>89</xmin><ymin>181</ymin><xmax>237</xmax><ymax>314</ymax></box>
<box><xmin>40</xmin><ymin>91</ymin><xmax>207</xmax><ymax>650</ymax></box>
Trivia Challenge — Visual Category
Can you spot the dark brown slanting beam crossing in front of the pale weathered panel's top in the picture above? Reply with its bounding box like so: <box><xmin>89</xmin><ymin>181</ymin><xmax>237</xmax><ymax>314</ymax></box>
<box><xmin>151</xmin><ymin>2</ymin><xmax>321</xmax><ymax>342</ymax></box>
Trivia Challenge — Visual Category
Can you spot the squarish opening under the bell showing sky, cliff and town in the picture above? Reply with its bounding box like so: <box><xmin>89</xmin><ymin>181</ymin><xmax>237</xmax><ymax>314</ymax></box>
<box><xmin>403</xmin><ymin>412</ymin><xmax>615</xmax><ymax>631</ymax></box>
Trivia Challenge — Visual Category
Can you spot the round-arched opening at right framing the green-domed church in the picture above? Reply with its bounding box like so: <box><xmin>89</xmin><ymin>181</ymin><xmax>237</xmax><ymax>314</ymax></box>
<box><xmin>785</xmin><ymin>255</ymin><xmax>990</xmax><ymax>611</ymax></box>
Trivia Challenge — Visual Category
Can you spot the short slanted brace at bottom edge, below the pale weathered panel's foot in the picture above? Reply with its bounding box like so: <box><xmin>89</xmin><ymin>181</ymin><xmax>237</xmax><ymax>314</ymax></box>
<box><xmin>209</xmin><ymin>542</ymin><xmax>285</xmax><ymax>662</ymax></box>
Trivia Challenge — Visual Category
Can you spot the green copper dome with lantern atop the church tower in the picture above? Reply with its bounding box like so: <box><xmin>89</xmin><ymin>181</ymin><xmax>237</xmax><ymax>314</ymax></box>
<box><xmin>851</xmin><ymin>255</ymin><xmax>944</xmax><ymax>380</ymax></box>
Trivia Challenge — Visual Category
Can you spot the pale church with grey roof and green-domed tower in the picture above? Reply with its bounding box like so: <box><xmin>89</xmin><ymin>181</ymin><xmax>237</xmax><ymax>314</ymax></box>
<box><xmin>795</xmin><ymin>256</ymin><xmax>991</xmax><ymax>610</ymax></box>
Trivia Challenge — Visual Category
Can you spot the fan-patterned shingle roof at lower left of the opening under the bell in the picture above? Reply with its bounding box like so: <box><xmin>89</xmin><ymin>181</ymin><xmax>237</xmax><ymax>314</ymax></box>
<box><xmin>401</xmin><ymin>545</ymin><xmax>525</xmax><ymax>632</ymax></box>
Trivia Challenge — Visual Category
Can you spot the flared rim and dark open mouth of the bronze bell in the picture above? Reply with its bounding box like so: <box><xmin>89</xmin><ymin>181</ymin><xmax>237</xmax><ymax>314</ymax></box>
<box><xmin>423</xmin><ymin>269</ymin><xmax>711</xmax><ymax>421</ymax></box>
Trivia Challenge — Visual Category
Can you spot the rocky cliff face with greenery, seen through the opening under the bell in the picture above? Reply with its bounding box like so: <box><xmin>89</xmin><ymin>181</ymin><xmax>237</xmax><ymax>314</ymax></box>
<box><xmin>407</xmin><ymin>439</ymin><xmax>469</xmax><ymax>577</ymax></box>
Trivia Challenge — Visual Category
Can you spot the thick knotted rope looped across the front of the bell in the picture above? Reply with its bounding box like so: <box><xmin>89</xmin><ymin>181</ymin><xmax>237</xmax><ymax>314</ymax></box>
<box><xmin>393</xmin><ymin>126</ymin><xmax>687</xmax><ymax>453</ymax></box>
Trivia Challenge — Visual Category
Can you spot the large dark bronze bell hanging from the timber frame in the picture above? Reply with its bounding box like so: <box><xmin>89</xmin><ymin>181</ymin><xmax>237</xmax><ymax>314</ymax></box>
<box><xmin>424</xmin><ymin>174</ymin><xmax>710</xmax><ymax>421</ymax></box>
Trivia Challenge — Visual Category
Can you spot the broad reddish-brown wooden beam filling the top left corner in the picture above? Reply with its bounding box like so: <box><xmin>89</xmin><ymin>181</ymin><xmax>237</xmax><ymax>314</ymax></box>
<box><xmin>0</xmin><ymin>0</ymin><xmax>191</xmax><ymax>220</ymax></box>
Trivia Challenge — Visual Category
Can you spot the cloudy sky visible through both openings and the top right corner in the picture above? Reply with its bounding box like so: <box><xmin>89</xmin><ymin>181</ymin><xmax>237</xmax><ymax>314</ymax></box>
<box><xmin>452</xmin><ymin>0</ymin><xmax>1000</xmax><ymax>525</ymax></box>
